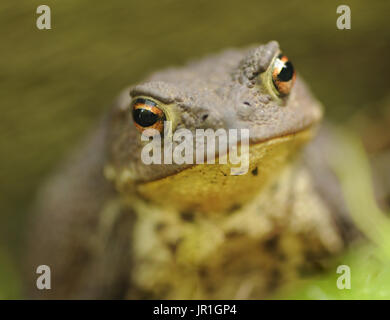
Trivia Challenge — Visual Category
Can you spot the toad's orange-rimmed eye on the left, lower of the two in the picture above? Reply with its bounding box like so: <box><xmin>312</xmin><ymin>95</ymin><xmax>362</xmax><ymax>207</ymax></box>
<box><xmin>133</xmin><ymin>98</ymin><xmax>165</xmax><ymax>132</ymax></box>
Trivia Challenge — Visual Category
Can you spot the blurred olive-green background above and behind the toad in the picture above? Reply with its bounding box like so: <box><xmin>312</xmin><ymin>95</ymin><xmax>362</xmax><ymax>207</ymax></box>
<box><xmin>0</xmin><ymin>0</ymin><xmax>390</xmax><ymax>298</ymax></box>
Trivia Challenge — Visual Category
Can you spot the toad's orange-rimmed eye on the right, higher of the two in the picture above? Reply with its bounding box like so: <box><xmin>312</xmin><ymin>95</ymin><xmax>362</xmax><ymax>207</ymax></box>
<box><xmin>272</xmin><ymin>54</ymin><xmax>295</xmax><ymax>97</ymax></box>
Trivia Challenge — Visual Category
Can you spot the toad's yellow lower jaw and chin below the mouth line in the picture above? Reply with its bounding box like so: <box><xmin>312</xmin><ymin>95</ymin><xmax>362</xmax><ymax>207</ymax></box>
<box><xmin>136</xmin><ymin>129</ymin><xmax>313</xmax><ymax>212</ymax></box>
